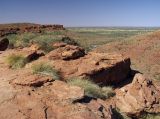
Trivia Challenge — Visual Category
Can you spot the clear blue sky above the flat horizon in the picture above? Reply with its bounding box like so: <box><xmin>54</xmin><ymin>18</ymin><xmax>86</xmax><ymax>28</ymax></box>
<box><xmin>0</xmin><ymin>0</ymin><xmax>160</xmax><ymax>27</ymax></box>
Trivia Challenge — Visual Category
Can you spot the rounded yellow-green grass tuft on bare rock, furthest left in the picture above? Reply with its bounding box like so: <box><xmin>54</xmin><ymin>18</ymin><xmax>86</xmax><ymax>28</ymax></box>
<box><xmin>6</xmin><ymin>54</ymin><xmax>27</xmax><ymax>69</ymax></box>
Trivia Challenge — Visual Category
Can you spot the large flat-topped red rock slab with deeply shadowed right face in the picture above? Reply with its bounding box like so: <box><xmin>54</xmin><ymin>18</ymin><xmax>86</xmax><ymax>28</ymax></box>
<box><xmin>53</xmin><ymin>52</ymin><xmax>130</xmax><ymax>84</ymax></box>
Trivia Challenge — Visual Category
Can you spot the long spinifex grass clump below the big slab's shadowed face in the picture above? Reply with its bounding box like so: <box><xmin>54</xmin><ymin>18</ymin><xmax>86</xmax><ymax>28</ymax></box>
<box><xmin>68</xmin><ymin>78</ymin><xmax>114</xmax><ymax>99</ymax></box>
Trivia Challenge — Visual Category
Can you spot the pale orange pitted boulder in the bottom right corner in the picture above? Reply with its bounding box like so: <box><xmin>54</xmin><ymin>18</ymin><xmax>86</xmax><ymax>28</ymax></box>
<box><xmin>116</xmin><ymin>74</ymin><xmax>160</xmax><ymax>115</ymax></box>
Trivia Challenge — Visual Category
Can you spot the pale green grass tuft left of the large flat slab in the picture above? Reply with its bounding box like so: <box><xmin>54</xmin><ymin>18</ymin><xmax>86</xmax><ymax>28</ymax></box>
<box><xmin>32</xmin><ymin>62</ymin><xmax>60</xmax><ymax>80</ymax></box>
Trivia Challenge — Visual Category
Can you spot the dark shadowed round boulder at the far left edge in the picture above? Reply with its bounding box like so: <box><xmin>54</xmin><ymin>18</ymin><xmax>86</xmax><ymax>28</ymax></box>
<box><xmin>0</xmin><ymin>38</ymin><xmax>9</xmax><ymax>51</ymax></box>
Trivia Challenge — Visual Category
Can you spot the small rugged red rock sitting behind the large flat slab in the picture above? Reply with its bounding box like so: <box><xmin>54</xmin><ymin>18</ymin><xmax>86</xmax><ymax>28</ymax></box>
<box><xmin>47</xmin><ymin>45</ymin><xmax>85</xmax><ymax>60</ymax></box>
